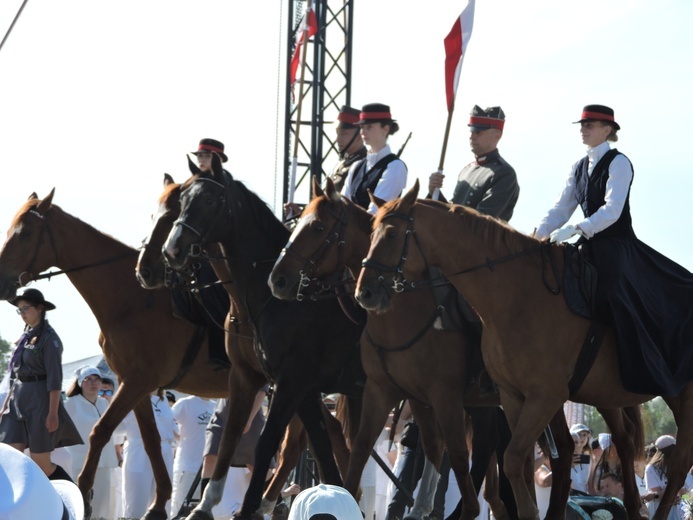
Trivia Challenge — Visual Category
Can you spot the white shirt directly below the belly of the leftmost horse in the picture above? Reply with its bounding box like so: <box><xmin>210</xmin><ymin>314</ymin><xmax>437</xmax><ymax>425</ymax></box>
<box><xmin>171</xmin><ymin>395</ymin><xmax>214</xmax><ymax>472</ymax></box>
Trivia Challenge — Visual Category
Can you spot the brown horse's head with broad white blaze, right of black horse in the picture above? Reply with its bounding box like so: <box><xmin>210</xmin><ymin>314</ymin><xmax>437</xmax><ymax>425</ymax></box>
<box><xmin>268</xmin><ymin>178</ymin><xmax>348</xmax><ymax>300</ymax></box>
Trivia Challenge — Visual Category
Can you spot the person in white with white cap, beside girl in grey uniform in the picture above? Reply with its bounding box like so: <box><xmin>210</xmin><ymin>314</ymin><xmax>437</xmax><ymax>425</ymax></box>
<box><xmin>65</xmin><ymin>365</ymin><xmax>118</xmax><ymax>520</ymax></box>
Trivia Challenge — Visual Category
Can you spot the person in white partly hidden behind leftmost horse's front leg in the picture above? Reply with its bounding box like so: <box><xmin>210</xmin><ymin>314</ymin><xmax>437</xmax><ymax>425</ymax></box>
<box><xmin>116</xmin><ymin>392</ymin><xmax>176</xmax><ymax>518</ymax></box>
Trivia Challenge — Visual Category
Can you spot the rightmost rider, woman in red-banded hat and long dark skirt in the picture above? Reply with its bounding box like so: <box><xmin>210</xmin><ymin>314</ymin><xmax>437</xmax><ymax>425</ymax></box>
<box><xmin>536</xmin><ymin>105</ymin><xmax>693</xmax><ymax>395</ymax></box>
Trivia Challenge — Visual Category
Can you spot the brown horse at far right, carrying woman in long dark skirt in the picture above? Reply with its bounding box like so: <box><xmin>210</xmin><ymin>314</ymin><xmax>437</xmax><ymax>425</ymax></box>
<box><xmin>357</xmin><ymin>182</ymin><xmax>693</xmax><ymax>520</ymax></box>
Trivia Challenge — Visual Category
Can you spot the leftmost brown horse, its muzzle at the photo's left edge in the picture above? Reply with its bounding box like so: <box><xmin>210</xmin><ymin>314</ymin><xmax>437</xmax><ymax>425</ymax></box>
<box><xmin>0</xmin><ymin>191</ymin><xmax>228</xmax><ymax>520</ymax></box>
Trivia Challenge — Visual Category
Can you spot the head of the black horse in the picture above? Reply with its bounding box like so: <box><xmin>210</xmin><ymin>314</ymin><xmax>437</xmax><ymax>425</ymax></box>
<box><xmin>163</xmin><ymin>153</ymin><xmax>233</xmax><ymax>272</ymax></box>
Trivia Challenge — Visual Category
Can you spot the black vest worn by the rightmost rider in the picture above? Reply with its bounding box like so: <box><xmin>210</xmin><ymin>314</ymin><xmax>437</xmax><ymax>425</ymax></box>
<box><xmin>575</xmin><ymin>148</ymin><xmax>633</xmax><ymax>238</ymax></box>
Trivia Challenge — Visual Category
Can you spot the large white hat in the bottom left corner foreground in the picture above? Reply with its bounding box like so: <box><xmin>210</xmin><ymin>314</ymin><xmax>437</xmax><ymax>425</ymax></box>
<box><xmin>0</xmin><ymin>444</ymin><xmax>84</xmax><ymax>520</ymax></box>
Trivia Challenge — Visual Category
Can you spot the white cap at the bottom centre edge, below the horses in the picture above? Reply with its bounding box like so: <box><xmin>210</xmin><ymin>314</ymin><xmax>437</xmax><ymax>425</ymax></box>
<box><xmin>289</xmin><ymin>484</ymin><xmax>363</xmax><ymax>520</ymax></box>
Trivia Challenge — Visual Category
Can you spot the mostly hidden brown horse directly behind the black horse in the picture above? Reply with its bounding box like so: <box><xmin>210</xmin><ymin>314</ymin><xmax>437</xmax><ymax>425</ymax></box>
<box><xmin>135</xmin><ymin>174</ymin><xmax>356</xmax><ymax>514</ymax></box>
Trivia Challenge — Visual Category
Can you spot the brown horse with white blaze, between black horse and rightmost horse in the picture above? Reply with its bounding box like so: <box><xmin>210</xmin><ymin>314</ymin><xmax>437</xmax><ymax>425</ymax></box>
<box><xmin>269</xmin><ymin>179</ymin><xmax>510</xmax><ymax>519</ymax></box>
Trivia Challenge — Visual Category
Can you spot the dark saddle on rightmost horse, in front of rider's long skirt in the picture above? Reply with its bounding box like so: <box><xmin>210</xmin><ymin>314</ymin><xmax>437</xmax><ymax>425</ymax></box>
<box><xmin>563</xmin><ymin>244</ymin><xmax>597</xmax><ymax>319</ymax></box>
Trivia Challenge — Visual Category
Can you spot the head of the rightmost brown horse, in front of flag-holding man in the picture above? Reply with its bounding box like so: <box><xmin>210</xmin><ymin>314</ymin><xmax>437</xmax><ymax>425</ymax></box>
<box><xmin>355</xmin><ymin>180</ymin><xmax>425</xmax><ymax>312</ymax></box>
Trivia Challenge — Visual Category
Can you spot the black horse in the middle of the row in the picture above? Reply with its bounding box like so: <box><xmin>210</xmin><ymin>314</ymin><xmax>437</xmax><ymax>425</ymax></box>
<box><xmin>157</xmin><ymin>156</ymin><xmax>363</xmax><ymax>518</ymax></box>
